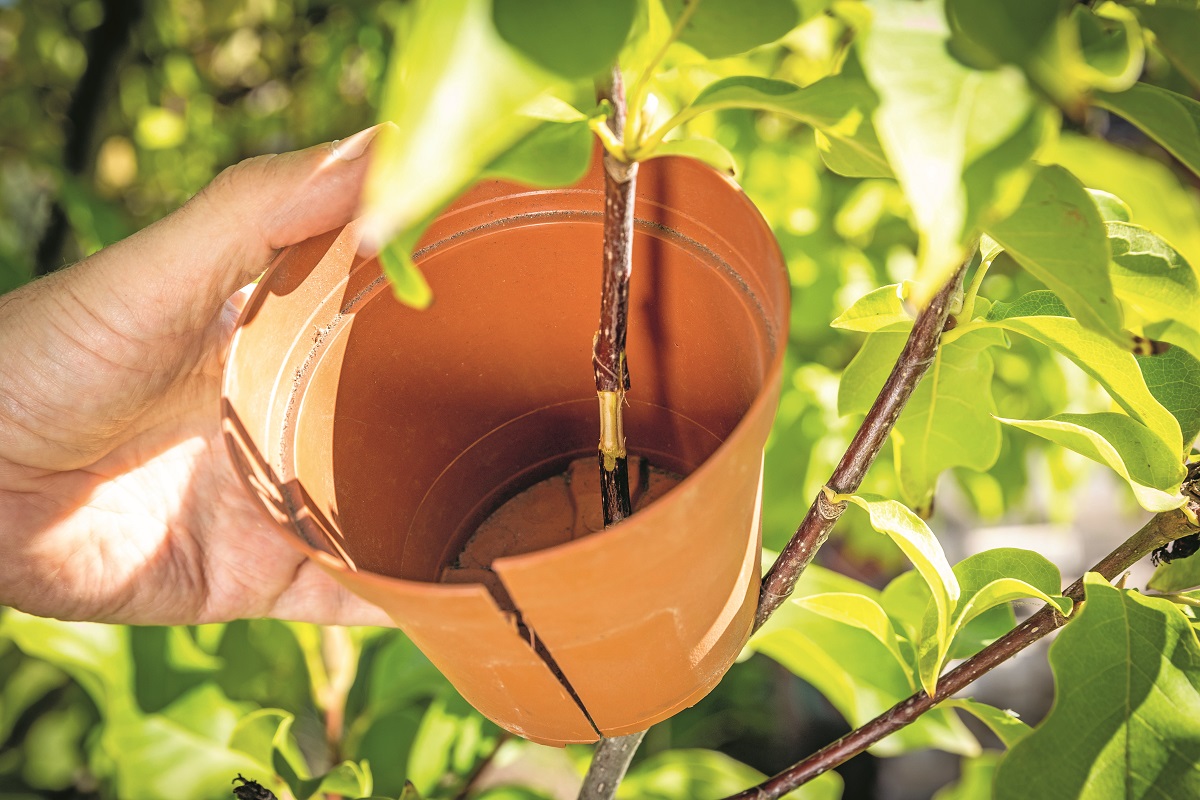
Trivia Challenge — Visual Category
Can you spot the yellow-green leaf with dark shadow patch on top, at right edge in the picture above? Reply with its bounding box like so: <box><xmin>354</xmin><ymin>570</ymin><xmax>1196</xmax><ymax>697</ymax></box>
<box><xmin>1106</xmin><ymin>222</ymin><xmax>1200</xmax><ymax>355</ymax></box>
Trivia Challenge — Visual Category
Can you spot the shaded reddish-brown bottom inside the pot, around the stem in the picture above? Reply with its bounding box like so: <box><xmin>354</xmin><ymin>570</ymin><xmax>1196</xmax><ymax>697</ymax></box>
<box><xmin>442</xmin><ymin>456</ymin><xmax>683</xmax><ymax>612</ymax></box>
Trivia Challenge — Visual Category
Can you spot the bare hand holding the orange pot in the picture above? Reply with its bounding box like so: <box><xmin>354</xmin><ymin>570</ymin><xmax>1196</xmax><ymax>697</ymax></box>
<box><xmin>0</xmin><ymin>124</ymin><xmax>392</xmax><ymax>625</ymax></box>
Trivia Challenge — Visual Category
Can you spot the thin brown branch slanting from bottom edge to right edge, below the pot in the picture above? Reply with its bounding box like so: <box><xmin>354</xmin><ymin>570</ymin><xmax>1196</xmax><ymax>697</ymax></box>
<box><xmin>726</xmin><ymin>504</ymin><xmax>1196</xmax><ymax>800</ymax></box>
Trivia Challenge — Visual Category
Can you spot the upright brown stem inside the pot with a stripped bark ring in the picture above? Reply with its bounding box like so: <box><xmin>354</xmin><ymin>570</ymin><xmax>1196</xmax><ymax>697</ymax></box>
<box><xmin>592</xmin><ymin>67</ymin><xmax>637</xmax><ymax>528</ymax></box>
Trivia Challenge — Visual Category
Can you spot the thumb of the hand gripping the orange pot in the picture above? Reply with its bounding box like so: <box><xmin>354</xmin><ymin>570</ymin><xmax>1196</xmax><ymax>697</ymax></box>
<box><xmin>88</xmin><ymin>122</ymin><xmax>394</xmax><ymax>336</ymax></box>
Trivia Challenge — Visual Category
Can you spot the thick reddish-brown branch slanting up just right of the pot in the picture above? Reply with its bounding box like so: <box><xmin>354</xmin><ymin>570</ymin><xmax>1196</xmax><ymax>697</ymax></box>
<box><xmin>754</xmin><ymin>256</ymin><xmax>974</xmax><ymax>630</ymax></box>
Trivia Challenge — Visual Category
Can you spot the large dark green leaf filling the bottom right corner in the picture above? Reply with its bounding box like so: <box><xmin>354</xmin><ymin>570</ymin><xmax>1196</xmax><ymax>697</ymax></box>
<box><xmin>995</xmin><ymin>573</ymin><xmax>1200</xmax><ymax>800</ymax></box>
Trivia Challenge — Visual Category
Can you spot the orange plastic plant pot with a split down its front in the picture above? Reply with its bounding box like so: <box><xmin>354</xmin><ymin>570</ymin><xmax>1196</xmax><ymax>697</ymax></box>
<box><xmin>224</xmin><ymin>153</ymin><xmax>788</xmax><ymax>745</ymax></box>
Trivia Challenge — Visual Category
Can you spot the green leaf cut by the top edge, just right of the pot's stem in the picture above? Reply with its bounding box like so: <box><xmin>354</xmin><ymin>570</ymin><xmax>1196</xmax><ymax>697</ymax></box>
<box><xmin>662</xmin><ymin>0</ymin><xmax>803</xmax><ymax>59</ymax></box>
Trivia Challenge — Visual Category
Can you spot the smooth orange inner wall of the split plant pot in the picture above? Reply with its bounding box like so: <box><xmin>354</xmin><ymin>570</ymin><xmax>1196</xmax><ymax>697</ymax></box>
<box><xmin>281</xmin><ymin>211</ymin><xmax>773</xmax><ymax>581</ymax></box>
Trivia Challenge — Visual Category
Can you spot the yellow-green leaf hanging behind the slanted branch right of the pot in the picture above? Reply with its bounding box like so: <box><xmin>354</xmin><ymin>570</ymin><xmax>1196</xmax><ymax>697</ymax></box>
<box><xmin>838</xmin><ymin>329</ymin><xmax>1007</xmax><ymax>506</ymax></box>
